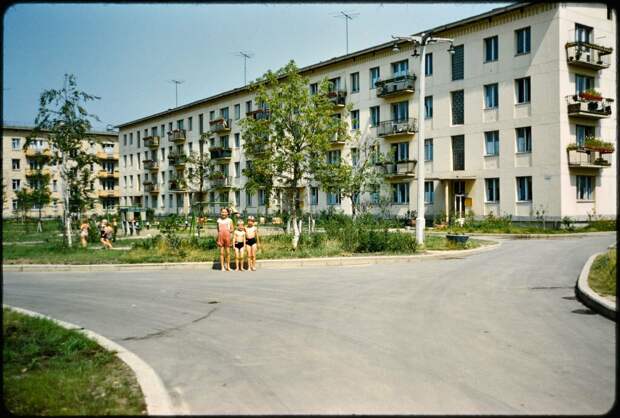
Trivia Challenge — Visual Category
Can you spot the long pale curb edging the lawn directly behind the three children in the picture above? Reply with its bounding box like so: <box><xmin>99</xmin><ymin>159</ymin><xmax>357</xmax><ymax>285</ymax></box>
<box><xmin>2</xmin><ymin>241</ymin><xmax>501</xmax><ymax>273</ymax></box>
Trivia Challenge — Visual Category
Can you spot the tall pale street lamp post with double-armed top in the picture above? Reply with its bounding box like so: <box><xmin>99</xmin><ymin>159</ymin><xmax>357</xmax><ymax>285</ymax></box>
<box><xmin>392</xmin><ymin>33</ymin><xmax>454</xmax><ymax>244</ymax></box>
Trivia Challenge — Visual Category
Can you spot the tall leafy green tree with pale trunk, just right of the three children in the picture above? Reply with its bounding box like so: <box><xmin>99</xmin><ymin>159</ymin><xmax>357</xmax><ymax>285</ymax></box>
<box><xmin>242</xmin><ymin>61</ymin><xmax>350</xmax><ymax>249</ymax></box>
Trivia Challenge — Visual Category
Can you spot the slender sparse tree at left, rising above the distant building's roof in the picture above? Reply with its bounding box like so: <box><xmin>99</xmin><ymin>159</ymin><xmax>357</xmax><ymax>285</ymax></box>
<box><xmin>24</xmin><ymin>74</ymin><xmax>99</xmax><ymax>246</ymax></box>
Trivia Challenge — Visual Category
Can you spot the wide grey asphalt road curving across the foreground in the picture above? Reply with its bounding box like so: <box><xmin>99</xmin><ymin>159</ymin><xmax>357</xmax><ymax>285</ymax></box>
<box><xmin>3</xmin><ymin>234</ymin><xmax>616</xmax><ymax>414</ymax></box>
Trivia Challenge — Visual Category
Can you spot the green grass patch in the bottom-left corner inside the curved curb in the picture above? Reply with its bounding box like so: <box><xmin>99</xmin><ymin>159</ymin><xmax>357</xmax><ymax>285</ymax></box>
<box><xmin>2</xmin><ymin>309</ymin><xmax>146</xmax><ymax>415</ymax></box>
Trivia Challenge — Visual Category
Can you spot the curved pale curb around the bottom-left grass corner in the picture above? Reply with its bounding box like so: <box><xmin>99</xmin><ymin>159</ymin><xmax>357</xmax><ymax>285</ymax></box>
<box><xmin>2</xmin><ymin>304</ymin><xmax>179</xmax><ymax>415</ymax></box>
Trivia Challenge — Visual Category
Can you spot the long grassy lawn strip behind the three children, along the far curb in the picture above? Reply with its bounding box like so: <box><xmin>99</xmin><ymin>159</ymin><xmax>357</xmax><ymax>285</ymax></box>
<box><xmin>2</xmin><ymin>234</ymin><xmax>490</xmax><ymax>264</ymax></box>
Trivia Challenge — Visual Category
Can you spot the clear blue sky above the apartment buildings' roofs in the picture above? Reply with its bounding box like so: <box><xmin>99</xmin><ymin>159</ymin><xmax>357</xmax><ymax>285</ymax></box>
<box><xmin>2</xmin><ymin>3</ymin><xmax>509</xmax><ymax>130</ymax></box>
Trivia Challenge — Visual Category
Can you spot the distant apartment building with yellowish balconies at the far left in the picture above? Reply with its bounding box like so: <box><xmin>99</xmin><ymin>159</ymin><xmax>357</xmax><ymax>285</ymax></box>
<box><xmin>2</xmin><ymin>125</ymin><xmax>120</xmax><ymax>218</ymax></box>
